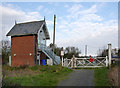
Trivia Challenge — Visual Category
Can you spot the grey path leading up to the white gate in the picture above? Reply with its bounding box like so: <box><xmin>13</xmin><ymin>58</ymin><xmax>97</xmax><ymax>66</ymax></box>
<box><xmin>58</xmin><ymin>69</ymin><xmax>94</xmax><ymax>86</ymax></box>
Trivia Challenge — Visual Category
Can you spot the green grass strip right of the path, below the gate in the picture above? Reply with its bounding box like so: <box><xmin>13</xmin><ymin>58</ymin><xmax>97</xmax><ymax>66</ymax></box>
<box><xmin>94</xmin><ymin>68</ymin><xmax>111</xmax><ymax>86</ymax></box>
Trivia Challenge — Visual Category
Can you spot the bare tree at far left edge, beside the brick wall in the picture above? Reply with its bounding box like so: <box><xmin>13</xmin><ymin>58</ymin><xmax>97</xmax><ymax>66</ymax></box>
<box><xmin>1</xmin><ymin>40</ymin><xmax>10</xmax><ymax>64</ymax></box>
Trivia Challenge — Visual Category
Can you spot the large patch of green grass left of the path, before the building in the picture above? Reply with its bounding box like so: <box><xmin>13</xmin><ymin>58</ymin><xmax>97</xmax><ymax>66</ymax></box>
<box><xmin>4</xmin><ymin>65</ymin><xmax>72</xmax><ymax>86</ymax></box>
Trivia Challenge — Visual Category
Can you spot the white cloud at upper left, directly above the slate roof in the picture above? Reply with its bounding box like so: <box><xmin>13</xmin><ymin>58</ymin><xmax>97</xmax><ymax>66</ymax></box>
<box><xmin>0</xmin><ymin>6</ymin><xmax>43</xmax><ymax>39</ymax></box>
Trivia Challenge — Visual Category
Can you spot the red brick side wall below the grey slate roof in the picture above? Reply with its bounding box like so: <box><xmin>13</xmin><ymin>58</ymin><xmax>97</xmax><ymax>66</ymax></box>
<box><xmin>11</xmin><ymin>35</ymin><xmax>36</xmax><ymax>66</ymax></box>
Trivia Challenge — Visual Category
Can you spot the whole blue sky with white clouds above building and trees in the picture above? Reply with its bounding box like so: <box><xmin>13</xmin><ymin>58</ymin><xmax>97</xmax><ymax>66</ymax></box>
<box><xmin>0</xmin><ymin>2</ymin><xmax>118</xmax><ymax>55</ymax></box>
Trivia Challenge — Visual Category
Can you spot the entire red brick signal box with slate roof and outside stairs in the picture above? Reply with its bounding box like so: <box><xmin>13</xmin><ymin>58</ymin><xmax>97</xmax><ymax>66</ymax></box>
<box><xmin>7</xmin><ymin>20</ymin><xmax>60</xmax><ymax>66</ymax></box>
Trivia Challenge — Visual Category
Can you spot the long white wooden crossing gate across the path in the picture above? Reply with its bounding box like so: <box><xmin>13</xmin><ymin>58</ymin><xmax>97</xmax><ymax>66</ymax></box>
<box><xmin>63</xmin><ymin>56</ymin><xmax>108</xmax><ymax>68</ymax></box>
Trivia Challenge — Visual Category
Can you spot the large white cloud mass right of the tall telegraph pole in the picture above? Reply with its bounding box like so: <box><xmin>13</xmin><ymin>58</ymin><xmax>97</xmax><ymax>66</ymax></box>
<box><xmin>56</xmin><ymin>5</ymin><xmax>118</xmax><ymax>54</ymax></box>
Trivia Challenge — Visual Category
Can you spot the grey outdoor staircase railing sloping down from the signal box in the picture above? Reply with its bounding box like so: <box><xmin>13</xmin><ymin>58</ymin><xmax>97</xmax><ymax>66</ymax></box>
<box><xmin>38</xmin><ymin>44</ymin><xmax>60</xmax><ymax>64</ymax></box>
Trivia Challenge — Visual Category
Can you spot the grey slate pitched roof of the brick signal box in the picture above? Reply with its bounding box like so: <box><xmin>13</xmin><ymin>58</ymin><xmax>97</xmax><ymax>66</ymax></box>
<box><xmin>6</xmin><ymin>20</ymin><xmax>50</xmax><ymax>39</ymax></box>
